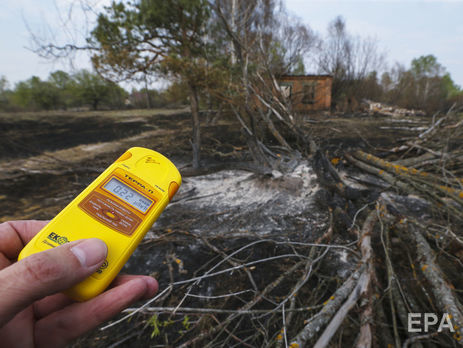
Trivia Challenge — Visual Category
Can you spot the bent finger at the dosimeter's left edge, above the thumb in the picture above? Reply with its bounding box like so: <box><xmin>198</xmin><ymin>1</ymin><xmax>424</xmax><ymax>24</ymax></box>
<box><xmin>0</xmin><ymin>220</ymin><xmax>48</xmax><ymax>260</ymax></box>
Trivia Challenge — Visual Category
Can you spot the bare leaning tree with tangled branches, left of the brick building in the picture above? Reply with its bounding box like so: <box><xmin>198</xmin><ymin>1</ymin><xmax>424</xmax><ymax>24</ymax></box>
<box><xmin>214</xmin><ymin>0</ymin><xmax>315</xmax><ymax>168</ymax></box>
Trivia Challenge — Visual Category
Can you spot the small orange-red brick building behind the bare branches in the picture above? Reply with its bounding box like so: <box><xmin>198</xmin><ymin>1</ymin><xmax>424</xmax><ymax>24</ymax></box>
<box><xmin>277</xmin><ymin>75</ymin><xmax>333</xmax><ymax>112</ymax></box>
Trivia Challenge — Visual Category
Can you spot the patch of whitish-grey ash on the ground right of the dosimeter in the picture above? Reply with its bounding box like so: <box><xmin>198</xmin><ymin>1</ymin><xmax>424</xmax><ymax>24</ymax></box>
<box><xmin>156</xmin><ymin>161</ymin><xmax>326</xmax><ymax>234</ymax></box>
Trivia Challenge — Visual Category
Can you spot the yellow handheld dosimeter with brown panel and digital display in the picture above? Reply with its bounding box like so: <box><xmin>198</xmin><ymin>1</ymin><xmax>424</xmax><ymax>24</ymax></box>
<box><xmin>19</xmin><ymin>147</ymin><xmax>182</xmax><ymax>301</ymax></box>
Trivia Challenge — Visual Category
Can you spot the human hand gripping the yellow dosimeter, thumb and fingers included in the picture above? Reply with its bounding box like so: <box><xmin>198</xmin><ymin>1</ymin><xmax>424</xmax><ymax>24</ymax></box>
<box><xmin>0</xmin><ymin>221</ymin><xmax>158</xmax><ymax>348</ymax></box>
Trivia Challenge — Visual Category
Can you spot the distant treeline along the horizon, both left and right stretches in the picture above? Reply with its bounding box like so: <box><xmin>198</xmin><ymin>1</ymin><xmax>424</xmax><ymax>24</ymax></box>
<box><xmin>0</xmin><ymin>55</ymin><xmax>463</xmax><ymax>113</ymax></box>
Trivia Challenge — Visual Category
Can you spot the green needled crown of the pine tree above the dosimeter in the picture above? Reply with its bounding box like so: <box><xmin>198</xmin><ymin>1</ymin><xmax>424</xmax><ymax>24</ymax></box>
<box><xmin>88</xmin><ymin>0</ymin><xmax>210</xmax><ymax>80</ymax></box>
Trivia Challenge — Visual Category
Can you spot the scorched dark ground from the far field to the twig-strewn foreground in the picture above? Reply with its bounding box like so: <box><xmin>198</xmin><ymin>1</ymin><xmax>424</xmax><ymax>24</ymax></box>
<box><xmin>0</xmin><ymin>111</ymin><xmax>463</xmax><ymax>347</ymax></box>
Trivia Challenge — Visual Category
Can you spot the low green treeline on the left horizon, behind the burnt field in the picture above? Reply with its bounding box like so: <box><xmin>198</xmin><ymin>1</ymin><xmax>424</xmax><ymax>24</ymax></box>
<box><xmin>0</xmin><ymin>70</ymin><xmax>190</xmax><ymax>112</ymax></box>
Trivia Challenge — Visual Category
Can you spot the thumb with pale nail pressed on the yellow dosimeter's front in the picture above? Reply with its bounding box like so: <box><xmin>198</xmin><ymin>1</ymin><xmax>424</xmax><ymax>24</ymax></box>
<box><xmin>0</xmin><ymin>238</ymin><xmax>108</xmax><ymax>327</ymax></box>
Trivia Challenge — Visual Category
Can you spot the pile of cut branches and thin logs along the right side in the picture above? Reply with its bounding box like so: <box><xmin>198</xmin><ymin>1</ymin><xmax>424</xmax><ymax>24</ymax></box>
<box><xmin>314</xmin><ymin>113</ymin><xmax>463</xmax><ymax>347</ymax></box>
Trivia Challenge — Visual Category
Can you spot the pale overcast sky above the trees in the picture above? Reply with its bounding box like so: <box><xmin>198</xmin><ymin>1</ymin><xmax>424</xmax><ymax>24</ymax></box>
<box><xmin>0</xmin><ymin>0</ymin><xmax>463</xmax><ymax>86</ymax></box>
